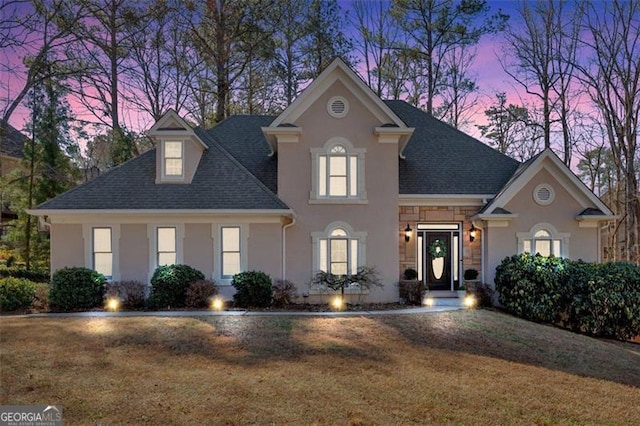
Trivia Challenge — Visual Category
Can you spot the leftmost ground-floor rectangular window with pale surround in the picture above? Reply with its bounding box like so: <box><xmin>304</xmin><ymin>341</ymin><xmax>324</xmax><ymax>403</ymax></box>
<box><xmin>82</xmin><ymin>223</ymin><xmax>120</xmax><ymax>281</ymax></box>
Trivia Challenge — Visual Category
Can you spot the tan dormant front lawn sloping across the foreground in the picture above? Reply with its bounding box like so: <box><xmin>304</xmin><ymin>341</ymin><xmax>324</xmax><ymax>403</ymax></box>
<box><xmin>0</xmin><ymin>311</ymin><xmax>640</xmax><ymax>425</ymax></box>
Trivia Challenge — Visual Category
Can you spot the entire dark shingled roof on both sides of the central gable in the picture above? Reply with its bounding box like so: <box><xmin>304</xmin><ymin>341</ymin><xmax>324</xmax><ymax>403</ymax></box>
<box><xmin>37</xmin><ymin>101</ymin><xmax>519</xmax><ymax>210</ymax></box>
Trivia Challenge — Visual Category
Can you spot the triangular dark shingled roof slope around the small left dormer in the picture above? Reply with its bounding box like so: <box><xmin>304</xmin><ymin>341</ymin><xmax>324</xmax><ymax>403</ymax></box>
<box><xmin>36</xmin><ymin>129</ymin><xmax>289</xmax><ymax>211</ymax></box>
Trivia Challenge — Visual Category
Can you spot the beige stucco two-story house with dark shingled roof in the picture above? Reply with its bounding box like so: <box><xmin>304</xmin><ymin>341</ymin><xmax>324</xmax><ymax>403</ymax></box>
<box><xmin>31</xmin><ymin>59</ymin><xmax>612</xmax><ymax>302</ymax></box>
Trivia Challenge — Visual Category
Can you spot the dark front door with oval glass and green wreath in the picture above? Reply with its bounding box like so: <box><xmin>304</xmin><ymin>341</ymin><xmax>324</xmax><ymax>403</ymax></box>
<box><xmin>424</xmin><ymin>232</ymin><xmax>452</xmax><ymax>290</ymax></box>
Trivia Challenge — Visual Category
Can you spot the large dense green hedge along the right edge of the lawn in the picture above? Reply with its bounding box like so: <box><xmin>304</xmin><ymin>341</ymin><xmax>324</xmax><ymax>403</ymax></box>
<box><xmin>495</xmin><ymin>253</ymin><xmax>640</xmax><ymax>340</ymax></box>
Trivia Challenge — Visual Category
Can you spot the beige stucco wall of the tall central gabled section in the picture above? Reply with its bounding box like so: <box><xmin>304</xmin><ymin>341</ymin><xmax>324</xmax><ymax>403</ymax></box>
<box><xmin>278</xmin><ymin>81</ymin><xmax>398</xmax><ymax>301</ymax></box>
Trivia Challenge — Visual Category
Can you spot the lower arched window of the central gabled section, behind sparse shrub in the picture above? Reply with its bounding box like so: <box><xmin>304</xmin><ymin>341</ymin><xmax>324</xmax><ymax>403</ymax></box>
<box><xmin>311</xmin><ymin>222</ymin><xmax>367</xmax><ymax>291</ymax></box>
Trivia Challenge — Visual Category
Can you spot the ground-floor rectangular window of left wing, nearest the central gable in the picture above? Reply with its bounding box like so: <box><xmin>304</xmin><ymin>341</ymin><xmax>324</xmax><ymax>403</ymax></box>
<box><xmin>211</xmin><ymin>223</ymin><xmax>249</xmax><ymax>285</ymax></box>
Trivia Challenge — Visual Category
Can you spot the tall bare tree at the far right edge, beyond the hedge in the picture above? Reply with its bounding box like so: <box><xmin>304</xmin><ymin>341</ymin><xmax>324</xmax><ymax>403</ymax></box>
<box><xmin>580</xmin><ymin>0</ymin><xmax>640</xmax><ymax>263</ymax></box>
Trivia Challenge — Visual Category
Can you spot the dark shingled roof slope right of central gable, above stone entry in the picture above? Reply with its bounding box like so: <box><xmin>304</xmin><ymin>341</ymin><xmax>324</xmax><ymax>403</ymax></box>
<box><xmin>386</xmin><ymin>101</ymin><xmax>520</xmax><ymax>194</ymax></box>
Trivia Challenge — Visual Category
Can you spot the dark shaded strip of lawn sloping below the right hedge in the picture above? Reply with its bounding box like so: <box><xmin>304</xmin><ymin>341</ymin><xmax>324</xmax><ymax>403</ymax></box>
<box><xmin>376</xmin><ymin>310</ymin><xmax>640</xmax><ymax>387</ymax></box>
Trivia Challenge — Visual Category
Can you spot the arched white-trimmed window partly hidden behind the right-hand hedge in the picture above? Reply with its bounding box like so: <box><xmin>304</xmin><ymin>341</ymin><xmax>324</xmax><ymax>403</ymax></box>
<box><xmin>517</xmin><ymin>223</ymin><xmax>571</xmax><ymax>257</ymax></box>
